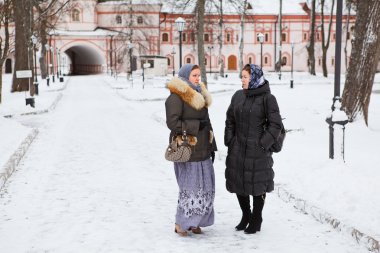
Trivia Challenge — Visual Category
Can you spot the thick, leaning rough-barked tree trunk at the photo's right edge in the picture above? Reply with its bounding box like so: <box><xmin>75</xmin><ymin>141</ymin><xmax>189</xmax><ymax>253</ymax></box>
<box><xmin>342</xmin><ymin>0</ymin><xmax>380</xmax><ymax>126</ymax></box>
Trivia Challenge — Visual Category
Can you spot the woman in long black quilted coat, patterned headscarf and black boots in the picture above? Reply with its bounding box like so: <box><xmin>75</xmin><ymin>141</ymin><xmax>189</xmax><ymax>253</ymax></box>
<box><xmin>224</xmin><ymin>64</ymin><xmax>282</xmax><ymax>234</ymax></box>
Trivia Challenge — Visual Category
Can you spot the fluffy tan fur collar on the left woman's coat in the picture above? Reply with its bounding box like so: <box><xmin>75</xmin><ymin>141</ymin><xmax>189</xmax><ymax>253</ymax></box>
<box><xmin>167</xmin><ymin>77</ymin><xmax>212</xmax><ymax>111</ymax></box>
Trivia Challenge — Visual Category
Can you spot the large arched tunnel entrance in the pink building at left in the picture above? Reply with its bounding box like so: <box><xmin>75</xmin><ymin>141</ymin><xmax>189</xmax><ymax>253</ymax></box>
<box><xmin>60</xmin><ymin>41</ymin><xmax>107</xmax><ymax>75</ymax></box>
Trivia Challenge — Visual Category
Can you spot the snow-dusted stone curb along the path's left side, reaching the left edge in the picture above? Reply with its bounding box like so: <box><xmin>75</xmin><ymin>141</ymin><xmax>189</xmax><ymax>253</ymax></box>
<box><xmin>0</xmin><ymin>129</ymin><xmax>39</xmax><ymax>190</ymax></box>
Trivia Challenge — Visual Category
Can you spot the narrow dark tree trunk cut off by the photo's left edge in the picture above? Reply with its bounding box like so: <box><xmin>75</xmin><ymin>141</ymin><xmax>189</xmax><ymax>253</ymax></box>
<box><xmin>0</xmin><ymin>0</ymin><xmax>12</xmax><ymax>104</ymax></box>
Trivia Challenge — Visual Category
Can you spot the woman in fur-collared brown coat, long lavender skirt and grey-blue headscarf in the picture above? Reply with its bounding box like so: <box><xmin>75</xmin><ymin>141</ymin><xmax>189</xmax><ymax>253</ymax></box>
<box><xmin>165</xmin><ymin>64</ymin><xmax>217</xmax><ymax>236</ymax></box>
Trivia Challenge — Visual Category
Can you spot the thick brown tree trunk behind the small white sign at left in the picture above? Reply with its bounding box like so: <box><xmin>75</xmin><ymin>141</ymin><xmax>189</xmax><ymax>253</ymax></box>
<box><xmin>11</xmin><ymin>0</ymin><xmax>32</xmax><ymax>95</ymax></box>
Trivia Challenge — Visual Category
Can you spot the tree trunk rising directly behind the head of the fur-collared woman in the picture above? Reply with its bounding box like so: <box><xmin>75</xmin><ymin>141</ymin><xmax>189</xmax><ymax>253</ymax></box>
<box><xmin>197</xmin><ymin>0</ymin><xmax>211</xmax><ymax>85</ymax></box>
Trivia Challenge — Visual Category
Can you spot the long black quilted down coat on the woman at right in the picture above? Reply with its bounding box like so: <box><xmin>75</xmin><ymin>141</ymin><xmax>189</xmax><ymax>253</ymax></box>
<box><xmin>224</xmin><ymin>81</ymin><xmax>282</xmax><ymax>196</ymax></box>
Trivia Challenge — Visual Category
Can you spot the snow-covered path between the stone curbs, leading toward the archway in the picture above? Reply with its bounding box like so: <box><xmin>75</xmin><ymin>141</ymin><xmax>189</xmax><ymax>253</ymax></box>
<box><xmin>0</xmin><ymin>76</ymin><xmax>366</xmax><ymax>253</ymax></box>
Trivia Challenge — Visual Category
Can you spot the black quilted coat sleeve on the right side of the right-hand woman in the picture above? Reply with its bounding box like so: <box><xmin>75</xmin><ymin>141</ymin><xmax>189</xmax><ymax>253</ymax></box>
<box><xmin>260</xmin><ymin>94</ymin><xmax>282</xmax><ymax>150</ymax></box>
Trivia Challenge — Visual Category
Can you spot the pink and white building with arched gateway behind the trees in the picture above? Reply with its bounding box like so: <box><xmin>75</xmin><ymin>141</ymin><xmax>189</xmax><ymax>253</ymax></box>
<box><xmin>5</xmin><ymin>0</ymin><xmax>355</xmax><ymax>74</ymax></box>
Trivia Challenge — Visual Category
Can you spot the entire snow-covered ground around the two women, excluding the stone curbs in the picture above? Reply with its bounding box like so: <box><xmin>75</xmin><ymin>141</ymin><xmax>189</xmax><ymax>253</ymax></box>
<box><xmin>0</xmin><ymin>73</ymin><xmax>380</xmax><ymax>253</ymax></box>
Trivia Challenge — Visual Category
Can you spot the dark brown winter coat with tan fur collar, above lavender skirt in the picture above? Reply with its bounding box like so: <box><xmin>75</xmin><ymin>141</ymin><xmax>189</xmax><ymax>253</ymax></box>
<box><xmin>165</xmin><ymin>78</ymin><xmax>217</xmax><ymax>162</ymax></box>
